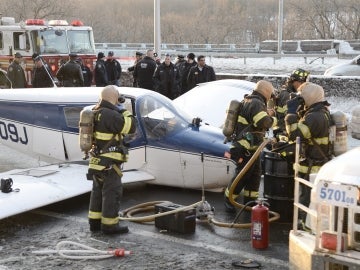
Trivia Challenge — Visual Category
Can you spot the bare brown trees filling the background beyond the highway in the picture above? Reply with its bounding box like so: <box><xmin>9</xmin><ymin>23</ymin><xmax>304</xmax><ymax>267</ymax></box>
<box><xmin>0</xmin><ymin>0</ymin><xmax>360</xmax><ymax>44</ymax></box>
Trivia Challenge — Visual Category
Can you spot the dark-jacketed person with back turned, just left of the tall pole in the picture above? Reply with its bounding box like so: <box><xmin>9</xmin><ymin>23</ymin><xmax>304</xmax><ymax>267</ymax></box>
<box><xmin>134</xmin><ymin>50</ymin><xmax>157</xmax><ymax>90</ymax></box>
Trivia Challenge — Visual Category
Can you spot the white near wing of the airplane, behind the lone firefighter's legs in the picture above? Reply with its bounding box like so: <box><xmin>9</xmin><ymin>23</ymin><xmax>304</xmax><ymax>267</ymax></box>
<box><xmin>0</xmin><ymin>163</ymin><xmax>155</xmax><ymax>219</ymax></box>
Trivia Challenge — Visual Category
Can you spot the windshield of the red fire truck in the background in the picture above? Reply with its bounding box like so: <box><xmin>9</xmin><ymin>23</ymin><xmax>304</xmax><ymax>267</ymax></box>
<box><xmin>30</xmin><ymin>28</ymin><xmax>95</xmax><ymax>54</ymax></box>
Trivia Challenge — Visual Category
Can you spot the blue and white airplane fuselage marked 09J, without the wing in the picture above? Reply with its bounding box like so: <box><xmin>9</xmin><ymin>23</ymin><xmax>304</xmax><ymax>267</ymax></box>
<box><xmin>0</xmin><ymin>87</ymin><xmax>235</xmax><ymax>189</ymax></box>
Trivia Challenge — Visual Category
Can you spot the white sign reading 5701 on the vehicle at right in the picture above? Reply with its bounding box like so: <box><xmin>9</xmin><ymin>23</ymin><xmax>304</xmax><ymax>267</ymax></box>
<box><xmin>316</xmin><ymin>180</ymin><xmax>358</xmax><ymax>207</ymax></box>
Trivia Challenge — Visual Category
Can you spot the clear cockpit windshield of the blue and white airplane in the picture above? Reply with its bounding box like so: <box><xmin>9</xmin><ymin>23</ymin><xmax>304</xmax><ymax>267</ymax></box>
<box><xmin>138</xmin><ymin>96</ymin><xmax>191</xmax><ymax>138</ymax></box>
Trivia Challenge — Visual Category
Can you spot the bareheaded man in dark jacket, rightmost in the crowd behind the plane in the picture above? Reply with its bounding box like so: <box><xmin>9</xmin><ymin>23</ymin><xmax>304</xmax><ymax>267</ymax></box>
<box><xmin>187</xmin><ymin>55</ymin><xmax>216</xmax><ymax>90</ymax></box>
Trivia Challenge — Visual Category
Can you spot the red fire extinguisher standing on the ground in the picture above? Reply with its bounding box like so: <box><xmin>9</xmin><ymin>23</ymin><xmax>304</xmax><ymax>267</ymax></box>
<box><xmin>251</xmin><ymin>198</ymin><xmax>269</xmax><ymax>249</ymax></box>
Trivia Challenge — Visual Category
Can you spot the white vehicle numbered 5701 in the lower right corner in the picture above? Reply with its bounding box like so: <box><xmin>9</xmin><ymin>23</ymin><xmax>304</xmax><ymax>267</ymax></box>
<box><xmin>289</xmin><ymin>142</ymin><xmax>360</xmax><ymax>270</ymax></box>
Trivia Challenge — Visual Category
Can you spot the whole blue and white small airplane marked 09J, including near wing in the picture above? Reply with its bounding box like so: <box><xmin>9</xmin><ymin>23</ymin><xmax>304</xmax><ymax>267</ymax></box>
<box><xmin>0</xmin><ymin>87</ymin><xmax>235</xmax><ymax>219</ymax></box>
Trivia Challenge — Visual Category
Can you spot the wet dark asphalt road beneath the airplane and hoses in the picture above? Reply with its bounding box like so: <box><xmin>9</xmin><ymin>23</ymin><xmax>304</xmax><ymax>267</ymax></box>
<box><xmin>0</xmin><ymin>181</ymin><xmax>291</xmax><ymax>270</ymax></box>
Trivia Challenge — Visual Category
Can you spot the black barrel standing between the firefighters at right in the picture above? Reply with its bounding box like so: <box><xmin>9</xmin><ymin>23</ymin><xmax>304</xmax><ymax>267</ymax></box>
<box><xmin>263</xmin><ymin>152</ymin><xmax>294</xmax><ymax>222</ymax></box>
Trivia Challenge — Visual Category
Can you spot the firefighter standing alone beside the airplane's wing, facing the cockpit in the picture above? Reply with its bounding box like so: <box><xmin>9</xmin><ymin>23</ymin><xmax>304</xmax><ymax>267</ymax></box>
<box><xmin>87</xmin><ymin>85</ymin><xmax>136</xmax><ymax>234</ymax></box>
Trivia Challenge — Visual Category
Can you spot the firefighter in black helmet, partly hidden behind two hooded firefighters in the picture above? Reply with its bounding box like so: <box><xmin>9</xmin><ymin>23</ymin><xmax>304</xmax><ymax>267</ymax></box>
<box><xmin>273</xmin><ymin>68</ymin><xmax>310</xmax><ymax>137</ymax></box>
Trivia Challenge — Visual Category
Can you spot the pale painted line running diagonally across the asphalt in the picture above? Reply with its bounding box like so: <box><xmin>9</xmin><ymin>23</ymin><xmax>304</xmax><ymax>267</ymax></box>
<box><xmin>31</xmin><ymin>209</ymin><xmax>289</xmax><ymax>266</ymax></box>
